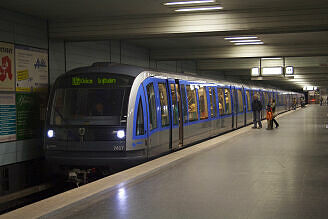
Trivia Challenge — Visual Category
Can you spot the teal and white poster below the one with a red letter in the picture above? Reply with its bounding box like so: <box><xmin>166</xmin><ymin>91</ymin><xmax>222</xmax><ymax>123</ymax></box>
<box><xmin>0</xmin><ymin>94</ymin><xmax>16</xmax><ymax>142</ymax></box>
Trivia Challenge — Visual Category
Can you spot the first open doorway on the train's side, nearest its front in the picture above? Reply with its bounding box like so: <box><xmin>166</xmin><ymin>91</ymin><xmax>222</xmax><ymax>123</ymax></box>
<box><xmin>168</xmin><ymin>79</ymin><xmax>183</xmax><ymax>150</ymax></box>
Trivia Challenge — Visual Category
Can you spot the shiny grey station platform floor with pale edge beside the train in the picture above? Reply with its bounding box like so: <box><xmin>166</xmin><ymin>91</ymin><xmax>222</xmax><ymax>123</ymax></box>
<box><xmin>0</xmin><ymin>105</ymin><xmax>328</xmax><ymax>219</ymax></box>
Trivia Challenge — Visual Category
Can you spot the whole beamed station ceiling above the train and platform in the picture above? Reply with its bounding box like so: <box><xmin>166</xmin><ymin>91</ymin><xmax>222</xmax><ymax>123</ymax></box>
<box><xmin>3</xmin><ymin>0</ymin><xmax>328</xmax><ymax>88</ymax></box>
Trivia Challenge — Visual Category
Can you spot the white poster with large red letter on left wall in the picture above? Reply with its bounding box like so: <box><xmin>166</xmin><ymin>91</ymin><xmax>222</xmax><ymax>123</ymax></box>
<box><xmin>0</xmin><ymin>42</ymin><xmax>15</xmax><ymax>91</ymax></box>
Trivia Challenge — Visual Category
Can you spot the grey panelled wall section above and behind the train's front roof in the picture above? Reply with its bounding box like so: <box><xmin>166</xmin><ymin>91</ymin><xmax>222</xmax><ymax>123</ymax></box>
<box><xmin>49</xmin><ymin>40</ymin><xmax>197</xmax><ymax>84</ymax></box>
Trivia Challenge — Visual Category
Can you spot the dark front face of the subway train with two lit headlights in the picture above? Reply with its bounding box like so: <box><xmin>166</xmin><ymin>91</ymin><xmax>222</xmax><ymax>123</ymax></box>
<box><xmin>45</xmin><ymin>68</ymin><xmax>143</xmax><ymax>182</ymax></box>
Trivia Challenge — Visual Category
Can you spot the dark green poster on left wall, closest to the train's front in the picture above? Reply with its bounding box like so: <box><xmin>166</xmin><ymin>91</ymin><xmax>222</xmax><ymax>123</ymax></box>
<box><xmin>16</xmin><ymin>93</ymin><xmax>41</xmax><ymax>140</ymax></box>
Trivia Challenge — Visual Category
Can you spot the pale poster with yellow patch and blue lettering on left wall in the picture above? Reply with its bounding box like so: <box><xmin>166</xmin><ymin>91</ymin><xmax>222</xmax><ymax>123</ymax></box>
<box><xmin>15</xmin><ymin>46</ymin><xmax>48</xmax><ymax>92</ymax></box>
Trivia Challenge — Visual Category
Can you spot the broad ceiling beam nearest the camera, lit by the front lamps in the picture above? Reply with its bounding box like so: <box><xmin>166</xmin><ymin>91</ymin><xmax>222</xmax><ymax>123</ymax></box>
<box><xmin>49</xmin><ymin>8</ymin><xmax>328</xmax><ymax>40</ymax></box>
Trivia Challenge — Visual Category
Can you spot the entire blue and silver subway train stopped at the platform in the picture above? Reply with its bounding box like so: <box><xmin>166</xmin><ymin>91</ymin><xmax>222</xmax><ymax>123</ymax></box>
<box><xmin>44</xmin><ymin>63</ymin><xmax>303</xmax><ymax>181</ymax></box>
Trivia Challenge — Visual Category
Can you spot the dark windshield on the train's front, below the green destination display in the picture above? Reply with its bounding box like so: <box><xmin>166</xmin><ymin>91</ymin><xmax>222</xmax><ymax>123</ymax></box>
<box><xmin>51</xmin><ymin>88</ymin><xmax>130</xmax><ymax>126</ymax></box>
